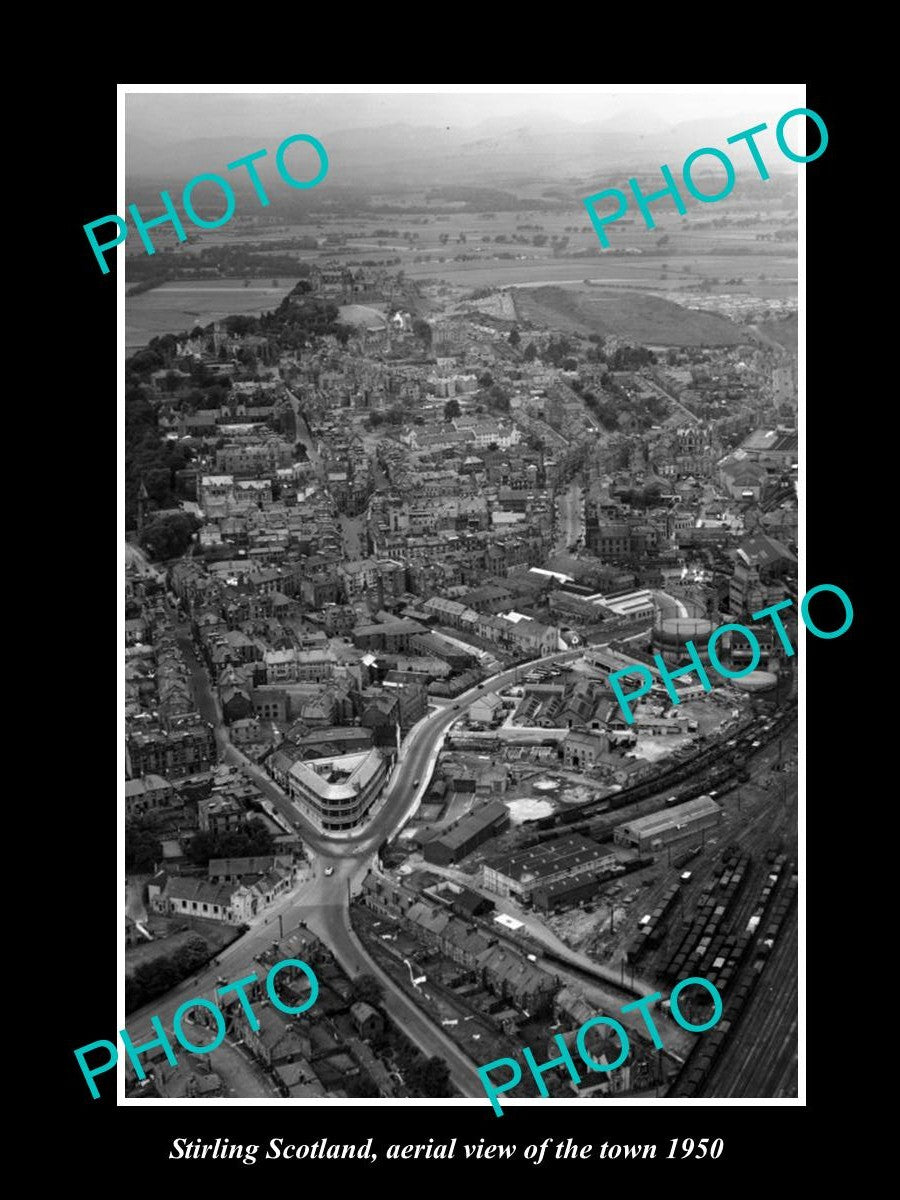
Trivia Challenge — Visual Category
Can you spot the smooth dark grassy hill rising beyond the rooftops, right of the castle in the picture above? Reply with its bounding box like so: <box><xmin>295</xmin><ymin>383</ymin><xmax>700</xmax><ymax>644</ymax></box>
<box><xmin>514</xmin><ymin>287</ymin><xmax>755</xmax><ymax>346</ymax></box>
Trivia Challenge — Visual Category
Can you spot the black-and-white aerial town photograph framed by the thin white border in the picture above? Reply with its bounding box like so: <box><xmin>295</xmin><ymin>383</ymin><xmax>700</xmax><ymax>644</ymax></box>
<box><xmin>121</xmin><ymin>85</ymin><xmax>801</xmax><ymax>1099</ymax></box>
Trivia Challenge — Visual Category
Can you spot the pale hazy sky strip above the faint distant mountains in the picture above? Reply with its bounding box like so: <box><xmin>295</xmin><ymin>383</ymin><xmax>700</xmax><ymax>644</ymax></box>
<box><xmin>124</xmin><ymin>84</ymin><xmax>804</xmax><ymax>144</ymax></box>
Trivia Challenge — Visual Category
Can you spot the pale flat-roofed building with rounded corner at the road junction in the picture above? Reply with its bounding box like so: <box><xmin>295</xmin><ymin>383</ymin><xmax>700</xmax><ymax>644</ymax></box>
<box><xmin>287</xmin><ymin>749</ymin><xmax>388</xmax><ymax>833</ymax></box>
